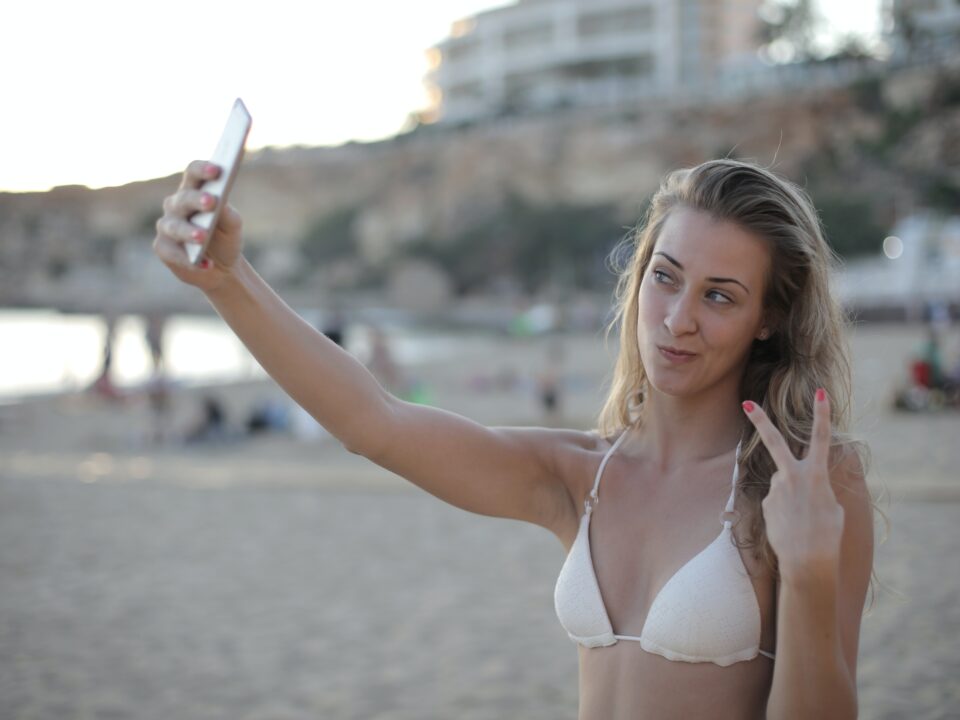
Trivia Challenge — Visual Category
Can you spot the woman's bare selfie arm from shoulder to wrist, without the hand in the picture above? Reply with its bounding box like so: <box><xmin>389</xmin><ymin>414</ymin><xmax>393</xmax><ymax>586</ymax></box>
<box><xmin>207</xmin><ymin>255</ymin><xmax>580</xmax><ymax>527</ymax></box>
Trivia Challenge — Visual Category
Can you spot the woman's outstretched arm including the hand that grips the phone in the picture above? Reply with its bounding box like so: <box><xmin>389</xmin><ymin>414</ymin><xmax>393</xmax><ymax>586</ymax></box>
<box><xmin>154</xmin><ymin>163</ymin><xmax>593</xmax><ymax>535</ymax></box>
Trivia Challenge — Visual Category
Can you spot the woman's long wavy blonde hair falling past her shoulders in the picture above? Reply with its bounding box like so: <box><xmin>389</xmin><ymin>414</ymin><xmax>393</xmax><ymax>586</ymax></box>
<box><xmin>597</xmin><ymin>159</ymin><xmax>869</xmax><ymax>577</ymax></box>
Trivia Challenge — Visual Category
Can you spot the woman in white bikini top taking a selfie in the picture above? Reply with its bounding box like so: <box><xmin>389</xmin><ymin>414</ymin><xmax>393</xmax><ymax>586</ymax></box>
<box><xmin>155</xmin><ymin>160</ymin><xmax>873</xmax><ymax>719</ymax></box>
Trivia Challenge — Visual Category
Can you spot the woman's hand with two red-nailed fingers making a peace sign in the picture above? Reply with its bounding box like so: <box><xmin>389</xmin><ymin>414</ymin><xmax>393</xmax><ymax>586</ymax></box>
<box><xmin>743</xmin><ymin>389</ymin><xmax>843</xmax><ymax>582</ymax></box>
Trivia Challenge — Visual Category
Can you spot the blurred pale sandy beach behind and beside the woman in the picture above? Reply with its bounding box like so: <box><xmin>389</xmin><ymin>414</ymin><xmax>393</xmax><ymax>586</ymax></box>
<box><xmin>0</xmin><ymin>326</ymin><xmax>960</xmax><ymax>720</ymax></box>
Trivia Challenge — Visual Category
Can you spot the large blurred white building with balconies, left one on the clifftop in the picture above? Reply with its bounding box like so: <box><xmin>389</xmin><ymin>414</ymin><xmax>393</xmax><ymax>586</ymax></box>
<box><xmin>427</xmin><ymin>0</ymin><xmax>762</xmax><ymax>122</ymax></box>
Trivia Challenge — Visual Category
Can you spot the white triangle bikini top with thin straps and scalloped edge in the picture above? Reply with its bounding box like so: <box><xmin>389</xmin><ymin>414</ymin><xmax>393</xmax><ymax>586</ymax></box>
<box><xmin>554</xmin><ymin>431</ymin><xmax>774</xmax><ymax>666</ymax></box>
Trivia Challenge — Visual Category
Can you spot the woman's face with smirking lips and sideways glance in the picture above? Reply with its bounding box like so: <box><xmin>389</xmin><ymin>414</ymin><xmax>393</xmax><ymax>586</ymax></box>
<box><xmin>637</xmin><ymin>206</ymin><xmax>770</xmax><ymax>396</ymax></box>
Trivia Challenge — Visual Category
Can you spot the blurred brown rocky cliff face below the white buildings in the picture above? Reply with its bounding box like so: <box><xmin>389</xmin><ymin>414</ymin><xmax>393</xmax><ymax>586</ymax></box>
<box><xmin>0</xmin><ymin>58</ymin><xmax>960</xmax><ymax>310</ymax></box>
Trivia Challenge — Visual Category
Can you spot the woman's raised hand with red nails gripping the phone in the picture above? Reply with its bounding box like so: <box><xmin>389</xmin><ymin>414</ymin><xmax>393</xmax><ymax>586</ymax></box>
<box><xmin>153</xmin><ymin>160</ymin><xmax>243</xmax><ymax>292</ymax></box>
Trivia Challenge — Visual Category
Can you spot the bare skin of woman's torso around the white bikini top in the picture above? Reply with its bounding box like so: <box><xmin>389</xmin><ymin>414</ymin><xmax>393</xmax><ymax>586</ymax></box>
<box><xmin>557</xmin><ymin>430</ymin><xmax>776</xmax><ymax>719</ymax></box>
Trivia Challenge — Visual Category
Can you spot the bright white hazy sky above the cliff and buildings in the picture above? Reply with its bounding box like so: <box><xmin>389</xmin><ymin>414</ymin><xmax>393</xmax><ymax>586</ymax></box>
<box><xmin>0</xmin><ymin>0</ymin><xmax>879</xmax><ymax>191</ymax></box>
